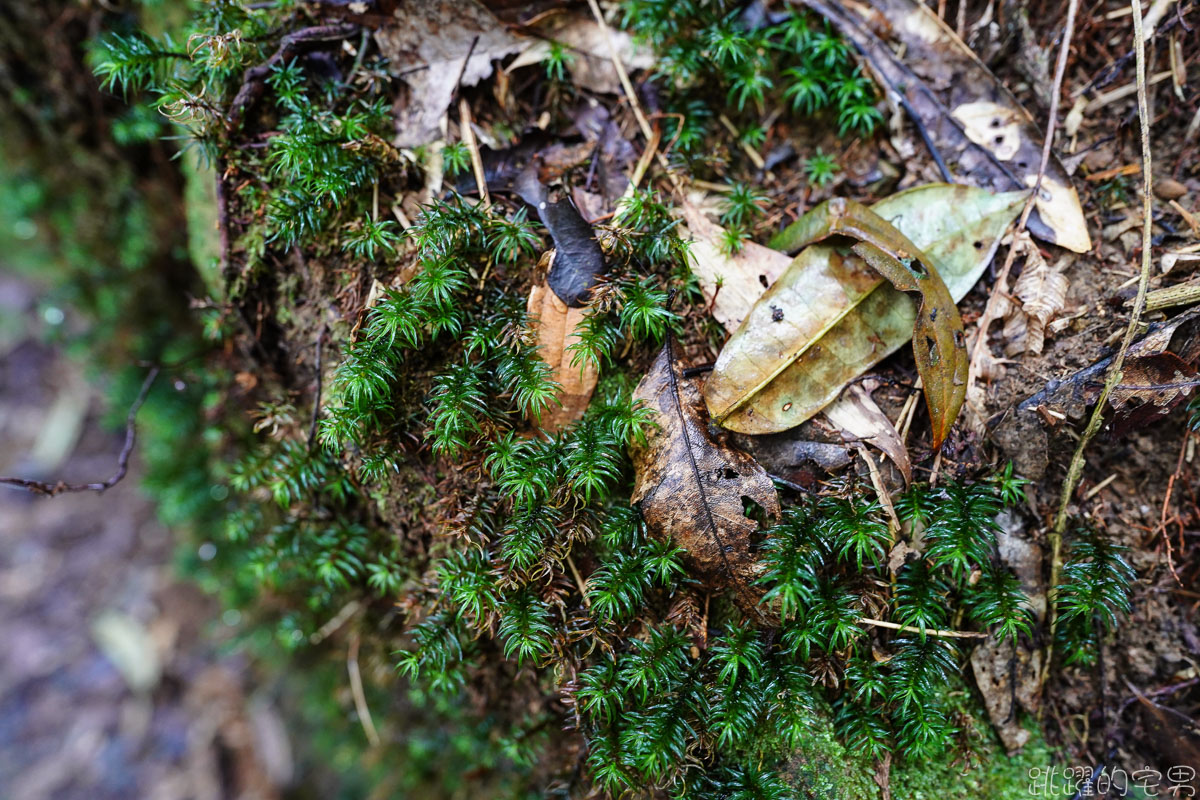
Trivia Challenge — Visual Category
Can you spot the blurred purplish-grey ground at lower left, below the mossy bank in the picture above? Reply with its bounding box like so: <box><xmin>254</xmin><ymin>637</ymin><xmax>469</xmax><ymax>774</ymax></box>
<box><xmin>0</xmin><ymin>273</ymin><xmax>283</xmax><ymax>800</ymax></box>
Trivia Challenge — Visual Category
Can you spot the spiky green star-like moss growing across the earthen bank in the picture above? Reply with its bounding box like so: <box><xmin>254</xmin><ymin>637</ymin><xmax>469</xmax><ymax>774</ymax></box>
<box><xmin>70</xmin><ymin>0</ymin><xmax>1137</xmax><ymax>798</ymax></box>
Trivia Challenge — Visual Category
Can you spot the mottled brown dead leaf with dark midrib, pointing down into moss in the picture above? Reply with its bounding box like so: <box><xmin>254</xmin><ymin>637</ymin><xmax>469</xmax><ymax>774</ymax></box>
<box><xmin>630</xmin><ymin>338</ymin><xmax>780</xmax><ymax>624</ymax></box>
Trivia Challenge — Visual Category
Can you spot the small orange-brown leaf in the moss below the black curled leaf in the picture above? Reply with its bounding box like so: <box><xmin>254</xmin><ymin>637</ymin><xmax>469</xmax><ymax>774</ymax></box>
<box><xmin>526</xmin><ymin>283</ymin><xmax>599</xmax><ymax>432</ymax></box>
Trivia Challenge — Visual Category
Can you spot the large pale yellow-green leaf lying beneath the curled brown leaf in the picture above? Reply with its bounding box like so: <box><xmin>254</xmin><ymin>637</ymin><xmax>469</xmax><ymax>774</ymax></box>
<box><xmin>704</xmin><ymin>184</ymin><xmax>1025</xmax><ymax>441</ymax></box>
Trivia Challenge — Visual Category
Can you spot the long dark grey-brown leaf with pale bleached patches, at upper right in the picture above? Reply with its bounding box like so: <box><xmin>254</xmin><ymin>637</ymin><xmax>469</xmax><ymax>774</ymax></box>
<box><xmin>804</xmin><ymin>0</ymin><xmax>1092</xmax><ymax>253</ymax></box>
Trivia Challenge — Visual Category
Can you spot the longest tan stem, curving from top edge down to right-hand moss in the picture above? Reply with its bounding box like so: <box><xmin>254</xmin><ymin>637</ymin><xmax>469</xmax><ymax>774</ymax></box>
<box><xmin>1040</xmin><ymin>0</ymin><xmax>1154</xmax><ymax>685</ymax></box>
